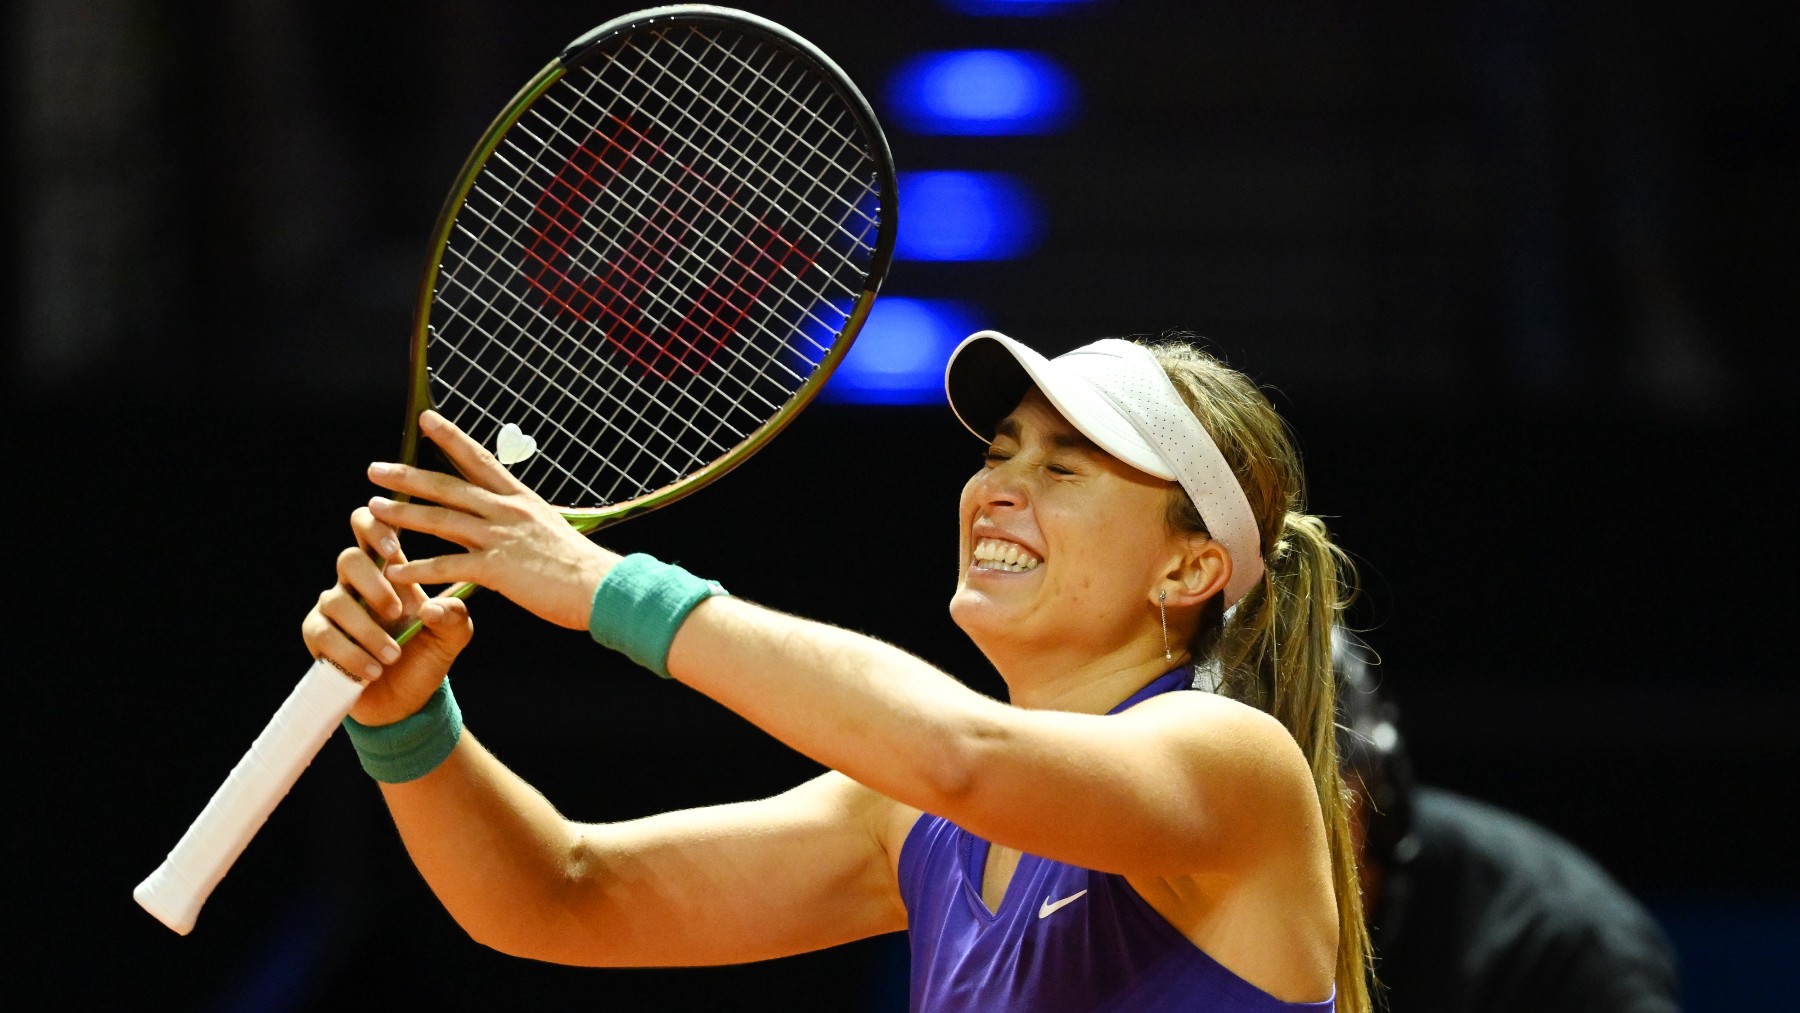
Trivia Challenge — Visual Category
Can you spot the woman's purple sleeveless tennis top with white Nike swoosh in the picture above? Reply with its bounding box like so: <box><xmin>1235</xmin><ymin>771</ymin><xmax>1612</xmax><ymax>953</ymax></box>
<box><xmin>900</xmin><ymin>668</ymin><xmax>1334</xmax><ymax>1013</ymax></box>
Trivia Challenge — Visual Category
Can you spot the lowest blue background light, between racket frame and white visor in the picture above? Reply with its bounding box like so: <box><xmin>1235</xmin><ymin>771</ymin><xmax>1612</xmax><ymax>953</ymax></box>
<box><xmin>819</xmin><ymin>295</ymin><xmax>981</xmax><ymax>405</ymax></box>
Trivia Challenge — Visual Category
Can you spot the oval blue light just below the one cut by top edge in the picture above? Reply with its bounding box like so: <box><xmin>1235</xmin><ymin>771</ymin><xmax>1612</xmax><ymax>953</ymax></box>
<box><xmin>887</xmin><ymin>49</ymin><xmax>1076</xmax><ymax>137</ymax></box>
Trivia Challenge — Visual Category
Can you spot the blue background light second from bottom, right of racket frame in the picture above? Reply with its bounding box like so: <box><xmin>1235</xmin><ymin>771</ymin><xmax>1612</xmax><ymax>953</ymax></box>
<box><xmin>895</xmin><ymin>171</ymin><xmax>1042</xmax><ymax>261</ymax></box>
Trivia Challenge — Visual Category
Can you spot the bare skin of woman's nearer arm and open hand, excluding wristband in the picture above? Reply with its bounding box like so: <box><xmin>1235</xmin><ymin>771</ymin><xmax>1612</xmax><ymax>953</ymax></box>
<box><xmin>371</xmin><ymin>412</ymin><xmax>1318</xmax><ymax>876</ymax></box>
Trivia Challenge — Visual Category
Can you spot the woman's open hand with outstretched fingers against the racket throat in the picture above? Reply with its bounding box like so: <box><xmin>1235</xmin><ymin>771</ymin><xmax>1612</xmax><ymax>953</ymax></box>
<box><xmin>369</xmin><ymin>412</ymin><xmax>619</xmax><ymax>630</ymax></box>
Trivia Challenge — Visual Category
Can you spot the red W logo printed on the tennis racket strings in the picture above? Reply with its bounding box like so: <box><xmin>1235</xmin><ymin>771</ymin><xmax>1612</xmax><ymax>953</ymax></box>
<box><xmin>520</xmin><ymin>117</ymin><xmax>815</xmax><ymax>380</ymax></box>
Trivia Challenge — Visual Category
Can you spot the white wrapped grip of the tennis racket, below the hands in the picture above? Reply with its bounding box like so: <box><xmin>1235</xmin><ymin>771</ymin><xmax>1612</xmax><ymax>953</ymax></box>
<box><xmin>131</xmin><ymin>660</ymin><xmax>362</xmax><ymax>936</ymax></box>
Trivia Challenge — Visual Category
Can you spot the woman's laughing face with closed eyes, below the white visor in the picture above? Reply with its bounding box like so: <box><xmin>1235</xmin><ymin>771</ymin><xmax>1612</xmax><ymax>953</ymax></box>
<box><xmin>950</xmin><ymin>389</ymin><xmax>1186</xmax><ymax>665</ymax></box>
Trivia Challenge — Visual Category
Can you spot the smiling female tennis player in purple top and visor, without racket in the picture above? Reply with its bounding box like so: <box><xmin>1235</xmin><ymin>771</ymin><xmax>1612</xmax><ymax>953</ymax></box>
<box><xmin>302</xmin><ymin>331</ymin><xmax>1368</xmax><ymax>1013</ymax></box>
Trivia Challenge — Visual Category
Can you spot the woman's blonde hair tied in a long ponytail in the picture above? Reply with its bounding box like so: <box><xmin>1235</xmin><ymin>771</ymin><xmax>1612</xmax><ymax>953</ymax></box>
<box><xmin>1141</xmin><ymin>333</ymin><xmax>1370</xmax><ymax>1013</ymax></box>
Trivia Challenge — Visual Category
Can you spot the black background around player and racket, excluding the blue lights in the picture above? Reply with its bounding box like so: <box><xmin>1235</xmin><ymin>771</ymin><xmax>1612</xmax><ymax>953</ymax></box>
<box><xmin>0</xmin><ymin>0</ymin><xmax>1800</xmax><ymax>1009</ymax></box>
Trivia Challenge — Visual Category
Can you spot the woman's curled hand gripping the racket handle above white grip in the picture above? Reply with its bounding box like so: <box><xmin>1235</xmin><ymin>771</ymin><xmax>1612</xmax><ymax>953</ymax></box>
<box><xmin>301</xmin><ymin>507</ymin><xmax>475</xmax><ymax>725</ymax></box>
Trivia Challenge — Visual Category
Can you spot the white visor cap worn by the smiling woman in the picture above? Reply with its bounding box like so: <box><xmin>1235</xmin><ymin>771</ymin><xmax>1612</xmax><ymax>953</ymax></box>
<box><xmin>943</xmin><ymin>331</ymin><xmax>1262</xmax><ymax>606</ymax></box>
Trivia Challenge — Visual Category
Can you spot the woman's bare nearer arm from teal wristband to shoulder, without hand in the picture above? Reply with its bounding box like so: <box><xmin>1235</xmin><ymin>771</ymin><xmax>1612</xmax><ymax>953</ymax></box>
<box><xmin>670</xmin><ymin>597</ymin><xmax>1319</xmax><ymax>876</ymax></box>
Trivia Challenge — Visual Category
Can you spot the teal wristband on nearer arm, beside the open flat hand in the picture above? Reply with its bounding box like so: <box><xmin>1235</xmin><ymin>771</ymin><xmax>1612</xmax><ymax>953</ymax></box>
<box><xmin>587</xmin><ymin>552</ymin><xmax>731</xmax><ymax>678</ymax></box>
